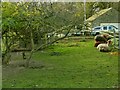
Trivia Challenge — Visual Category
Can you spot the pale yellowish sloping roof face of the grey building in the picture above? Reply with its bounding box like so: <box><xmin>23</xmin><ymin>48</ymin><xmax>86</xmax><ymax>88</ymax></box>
<box><xmin>86</xmin><ymin>8</ymin><xmax>112</xmax><ymax>21</ymax></box>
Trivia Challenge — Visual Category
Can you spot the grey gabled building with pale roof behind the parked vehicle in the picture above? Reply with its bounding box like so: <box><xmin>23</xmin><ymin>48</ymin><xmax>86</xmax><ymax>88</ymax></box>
<box><xmin>86</xmin><ymin>8</ymin><xmax>120</xmax><ymax>28</ymax></box>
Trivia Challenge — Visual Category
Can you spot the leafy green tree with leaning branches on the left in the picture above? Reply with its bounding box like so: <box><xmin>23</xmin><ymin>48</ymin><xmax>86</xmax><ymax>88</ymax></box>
<box><xmin>2</xmin><ymin>2</ymin><xmax>77</xmax><ymax>64</ymax></box>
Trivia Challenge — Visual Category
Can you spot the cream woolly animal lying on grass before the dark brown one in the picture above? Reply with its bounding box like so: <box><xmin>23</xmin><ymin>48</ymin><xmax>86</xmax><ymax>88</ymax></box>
<box><xmin>97</xmin><ymin>41</ymin><xmax>110</xmax><ymax>52</ymax></box>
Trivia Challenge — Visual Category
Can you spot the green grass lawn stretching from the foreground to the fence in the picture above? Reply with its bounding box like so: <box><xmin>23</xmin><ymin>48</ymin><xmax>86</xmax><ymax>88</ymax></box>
<box><xmin>3</xmin><ymin>40</ymin><xmax>118</xmax><ymax>88</ymax></box>
